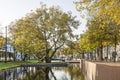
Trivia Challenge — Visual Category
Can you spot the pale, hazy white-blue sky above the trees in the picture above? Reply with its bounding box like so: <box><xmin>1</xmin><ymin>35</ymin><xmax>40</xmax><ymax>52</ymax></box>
<box><xmin>0</xmin><ymin>0</ymin><xmax>86</xmax><ymax>34</ymax></box>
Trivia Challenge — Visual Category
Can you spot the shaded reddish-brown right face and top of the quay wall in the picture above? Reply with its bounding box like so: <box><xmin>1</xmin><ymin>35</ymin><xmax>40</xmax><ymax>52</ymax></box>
<box><xmin>96</xmin><ymin>62</ymin><xmax>120</xmax><ymax>80</ymax></box>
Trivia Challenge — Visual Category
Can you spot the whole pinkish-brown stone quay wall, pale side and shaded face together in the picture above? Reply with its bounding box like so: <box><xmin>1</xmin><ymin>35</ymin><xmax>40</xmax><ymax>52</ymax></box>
<box><xmin>82</xmin><ymin>60</ymin><xmax>120</xmax><ymax>80</ymax></box>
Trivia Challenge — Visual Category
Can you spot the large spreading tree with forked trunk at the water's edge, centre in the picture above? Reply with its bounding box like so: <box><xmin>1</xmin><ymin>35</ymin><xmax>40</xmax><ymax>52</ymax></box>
<box><xmin>8</xmin><ymin>4</ymin><xmax>79</xmax><ymax>63</ymax></box>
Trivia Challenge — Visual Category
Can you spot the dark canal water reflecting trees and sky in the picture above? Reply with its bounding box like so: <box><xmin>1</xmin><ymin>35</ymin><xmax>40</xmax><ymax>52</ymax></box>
<box><xmin>0</xmin><ymin>64</ymin><xmax>83</xmax><ymax>80</ymax></box>
